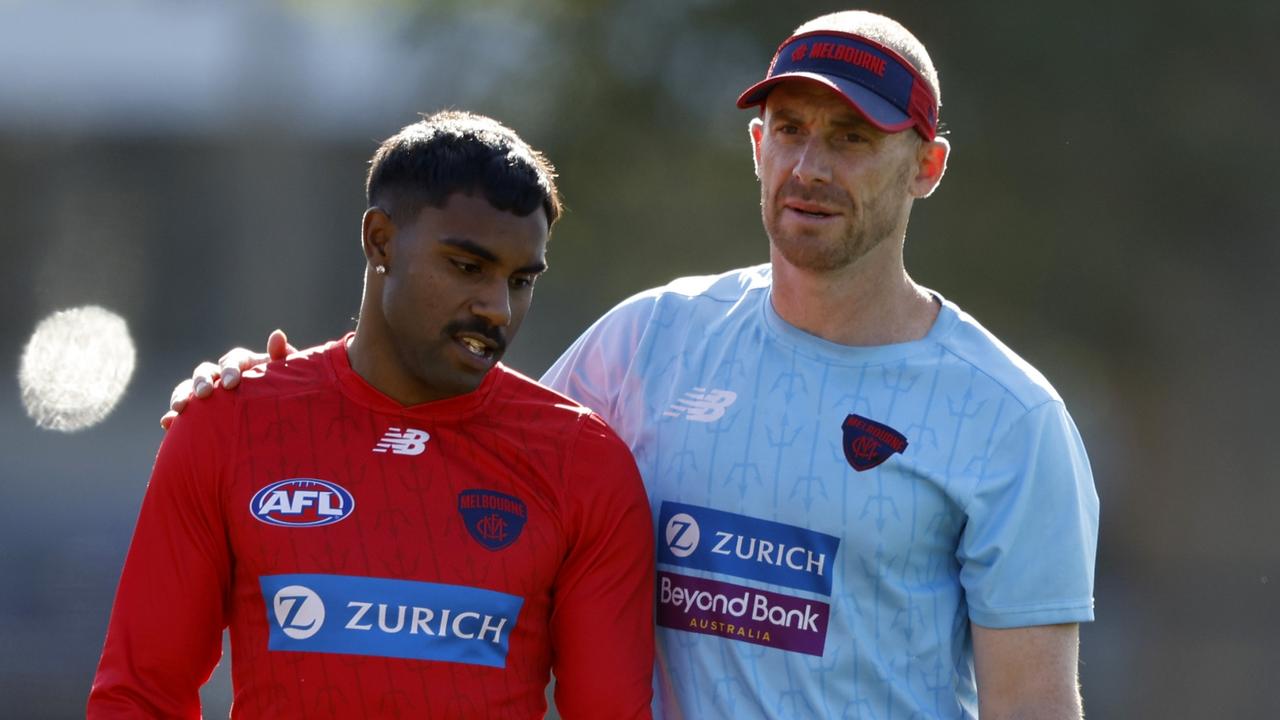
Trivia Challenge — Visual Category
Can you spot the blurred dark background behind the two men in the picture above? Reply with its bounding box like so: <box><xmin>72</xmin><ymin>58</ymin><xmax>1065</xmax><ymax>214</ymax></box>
<box><xmin>0</xmin><ymin>0</ymin><xmax>1280</xmax><ymax>720</ymax></box>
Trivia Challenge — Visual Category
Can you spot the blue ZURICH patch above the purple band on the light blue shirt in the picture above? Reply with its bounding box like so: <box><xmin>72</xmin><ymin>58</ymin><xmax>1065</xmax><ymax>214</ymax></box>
<box><xmin>658</xmin><ymin>501</ymin><xmax>840</xmax><ymax>594</ymax></box>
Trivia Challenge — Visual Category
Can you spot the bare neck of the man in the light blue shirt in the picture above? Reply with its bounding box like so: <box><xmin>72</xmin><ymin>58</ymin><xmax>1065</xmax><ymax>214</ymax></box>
<box><xmin>769</xmin><ymin>241</ymin><xmax>938</xmax><ymax>346</ymax></box>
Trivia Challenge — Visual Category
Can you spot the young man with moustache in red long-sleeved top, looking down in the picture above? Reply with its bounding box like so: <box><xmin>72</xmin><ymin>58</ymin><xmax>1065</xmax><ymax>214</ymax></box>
<box><xmin>88</xmin><ymin>113</ymin><xmax>654</xmax><ymax>717</ymax></box>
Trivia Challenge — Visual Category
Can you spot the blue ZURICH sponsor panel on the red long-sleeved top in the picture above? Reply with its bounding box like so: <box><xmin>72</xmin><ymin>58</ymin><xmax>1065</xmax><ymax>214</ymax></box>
<box><xmin>259</xmin><ymin>574</ymin><xmax>525</xmax><ymax>667</ymax></box>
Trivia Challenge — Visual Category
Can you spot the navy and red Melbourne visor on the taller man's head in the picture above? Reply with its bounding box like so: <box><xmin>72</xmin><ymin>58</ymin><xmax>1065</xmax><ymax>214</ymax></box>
<box><xmin>737</xmin><ymin>29</ymin><xmax>938</xmax><ymax>140</ymax></box>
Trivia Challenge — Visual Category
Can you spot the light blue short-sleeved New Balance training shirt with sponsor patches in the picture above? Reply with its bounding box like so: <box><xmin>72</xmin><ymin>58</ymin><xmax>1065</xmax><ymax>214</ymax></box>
<box><xmin>543</xmin><ymin>265</ymin><xmax>1098</xmax><ymax>720</ymax></box>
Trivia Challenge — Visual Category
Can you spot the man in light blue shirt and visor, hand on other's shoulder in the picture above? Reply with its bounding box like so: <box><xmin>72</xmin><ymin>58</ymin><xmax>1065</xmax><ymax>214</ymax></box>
<box><xmin>174</xmin><ymin>12</ymin><xmax>1098</xmax><ymax>720</ymax></box>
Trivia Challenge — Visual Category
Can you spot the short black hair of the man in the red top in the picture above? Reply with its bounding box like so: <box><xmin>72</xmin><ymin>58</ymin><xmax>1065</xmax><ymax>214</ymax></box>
<box><xmin>365</xmin><ymin>110</ymin><xmax>561</xmax><ymax>228</ymax></box>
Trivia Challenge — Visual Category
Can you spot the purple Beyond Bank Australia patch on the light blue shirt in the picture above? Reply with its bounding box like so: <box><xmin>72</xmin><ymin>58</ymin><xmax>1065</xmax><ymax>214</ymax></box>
<box><xmin>658</xmin><ymin>571</ymin><xmax>831</xmax><ymax>656</ymax></box>
